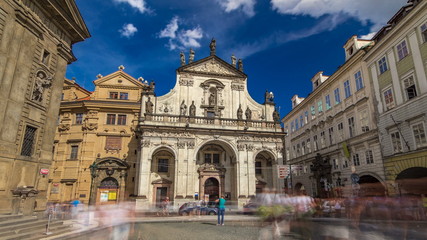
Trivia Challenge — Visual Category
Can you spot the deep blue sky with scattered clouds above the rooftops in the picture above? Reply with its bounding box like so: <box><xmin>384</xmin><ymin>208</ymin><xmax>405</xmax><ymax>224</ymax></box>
<box><xmin>66</xmin><ymin>0</ymin><xmax>406</xmax><ymax>117</ymax></box>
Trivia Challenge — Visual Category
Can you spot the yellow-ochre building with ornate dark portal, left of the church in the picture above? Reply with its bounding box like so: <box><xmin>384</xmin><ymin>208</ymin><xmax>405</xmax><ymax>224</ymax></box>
<box><xmin>49</xmin><ymin>66</ymin><xmax>149</xmax><ymax>204</ymax></box>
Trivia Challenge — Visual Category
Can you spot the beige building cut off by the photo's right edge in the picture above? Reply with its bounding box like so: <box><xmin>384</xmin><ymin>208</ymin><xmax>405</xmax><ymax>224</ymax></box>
<box><xmin>364</xmin><ymin>0</ymin><xmax>427</xmax><ymax>195</ymax></box>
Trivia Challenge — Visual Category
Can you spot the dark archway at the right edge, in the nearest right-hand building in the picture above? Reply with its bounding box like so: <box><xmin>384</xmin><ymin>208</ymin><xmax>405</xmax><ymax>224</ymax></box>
<box><xmin>396</xmin><ymin>167</ymin><xmax>427</xmax><ymax>195</ymax></box>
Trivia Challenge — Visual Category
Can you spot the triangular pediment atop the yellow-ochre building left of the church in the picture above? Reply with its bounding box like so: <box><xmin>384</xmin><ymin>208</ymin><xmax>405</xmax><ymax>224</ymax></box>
<box><xmin>93</xmin><ymin>70</ymin><xmax>146</xmax><ymax>88</ymax></box>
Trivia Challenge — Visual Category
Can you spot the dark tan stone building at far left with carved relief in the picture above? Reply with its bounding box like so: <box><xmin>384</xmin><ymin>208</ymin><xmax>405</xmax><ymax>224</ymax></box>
<box><xmin>0</xmin><ymin>0</ymin><xmax>90</xmax><ymax>214</ymax></box>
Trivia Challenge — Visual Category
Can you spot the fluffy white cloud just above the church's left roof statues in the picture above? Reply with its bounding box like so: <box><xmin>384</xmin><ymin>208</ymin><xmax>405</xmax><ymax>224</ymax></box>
<box><xmin>159</xmin><ymin>17</ymin><xmax>203</xmax><ymax>50</ymax></box>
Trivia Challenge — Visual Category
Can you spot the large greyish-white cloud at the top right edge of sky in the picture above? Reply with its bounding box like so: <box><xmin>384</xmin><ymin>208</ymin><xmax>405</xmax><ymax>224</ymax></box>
<box><xmin>271</xmin><ymin>0</ymin><xmax>407</xmax><ymax>31</ymax></box>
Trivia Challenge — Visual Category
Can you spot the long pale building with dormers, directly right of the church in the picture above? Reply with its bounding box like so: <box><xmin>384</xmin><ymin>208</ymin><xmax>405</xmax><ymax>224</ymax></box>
<box><xmin>282</xmin><ymin>36</ymin><xmax>385</xmax><ymax>197</ymax></box>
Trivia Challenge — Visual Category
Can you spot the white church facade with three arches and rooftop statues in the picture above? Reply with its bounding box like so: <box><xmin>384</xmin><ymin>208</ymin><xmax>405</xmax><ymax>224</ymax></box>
<box><xmin>135</xmin><ymin>40</ymin><xmax>284</xmax><ymax>209</ymax></box>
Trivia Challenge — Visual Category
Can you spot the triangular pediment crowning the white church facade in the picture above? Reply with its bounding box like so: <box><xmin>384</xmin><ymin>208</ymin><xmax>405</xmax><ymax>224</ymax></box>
<box><xmin>178</xmin><ymin>56</ymin><xmax>246</xmax><ymax>78</ymax></box>
